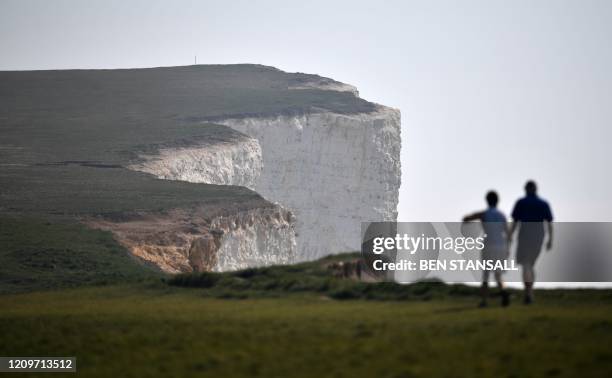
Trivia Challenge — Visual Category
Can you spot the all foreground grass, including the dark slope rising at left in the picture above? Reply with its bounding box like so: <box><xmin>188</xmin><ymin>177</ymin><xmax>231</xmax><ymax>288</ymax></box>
<box><xmin>0</xmin><ymin>244</ymin><xmax>612</xmax><ymax>378</ymax></box>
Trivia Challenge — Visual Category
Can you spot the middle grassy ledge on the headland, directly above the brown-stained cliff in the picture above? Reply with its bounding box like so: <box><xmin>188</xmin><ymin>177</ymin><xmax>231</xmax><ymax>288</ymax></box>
<box><xmin>0</xmin><ymin>164</ymin><xmax>271</xmax><ymax>216</ymax></box>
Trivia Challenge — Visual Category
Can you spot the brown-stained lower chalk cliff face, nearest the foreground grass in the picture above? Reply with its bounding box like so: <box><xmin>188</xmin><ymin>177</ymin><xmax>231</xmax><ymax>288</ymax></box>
<box><xmin>84</xmin><ymin>205</ymin><xmax>296</xmax><ymax>273</ymax></box>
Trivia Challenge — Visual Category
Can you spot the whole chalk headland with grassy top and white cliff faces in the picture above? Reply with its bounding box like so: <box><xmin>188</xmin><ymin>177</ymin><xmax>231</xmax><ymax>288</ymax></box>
<box><xmin>0</xmin><ymin>65</ymin><xmax>401</xmax><ymax>272</ymax></box>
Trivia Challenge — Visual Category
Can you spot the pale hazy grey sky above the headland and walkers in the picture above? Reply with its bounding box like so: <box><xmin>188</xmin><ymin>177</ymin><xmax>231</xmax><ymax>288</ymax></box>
<box><xmin>0</xmin><ymin>0</ymin><xmax>612</xmax><ymax>221</ymax></box>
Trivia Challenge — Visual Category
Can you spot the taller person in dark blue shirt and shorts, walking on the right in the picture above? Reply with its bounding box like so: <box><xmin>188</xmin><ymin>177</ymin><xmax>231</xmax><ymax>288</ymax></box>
<box><xmin>508</xmin><ymin>181</ymin><xmax>553</xmax><ymax>304</ymax></box>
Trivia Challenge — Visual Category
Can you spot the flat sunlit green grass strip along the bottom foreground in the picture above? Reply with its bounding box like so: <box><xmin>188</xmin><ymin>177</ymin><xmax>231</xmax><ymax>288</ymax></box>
<box><xmin>0</xmin><ymin>283</ymin><xmax>612</xmax><ymax>377</ymax></box>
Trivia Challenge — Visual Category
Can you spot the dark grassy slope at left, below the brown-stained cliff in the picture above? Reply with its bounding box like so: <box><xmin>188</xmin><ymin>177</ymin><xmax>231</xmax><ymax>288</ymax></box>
<box><xmin>0</xmin><ymin>217</ymin><xmax>161</xmax><ymax>294</ymax></box>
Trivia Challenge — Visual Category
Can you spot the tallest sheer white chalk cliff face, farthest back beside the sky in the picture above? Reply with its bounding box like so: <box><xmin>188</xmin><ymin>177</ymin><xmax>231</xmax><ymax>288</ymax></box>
<box><xmin>217</xmin><ymin>106</ymin><xmax>401</xmax><ymax>260</ymax></box>
